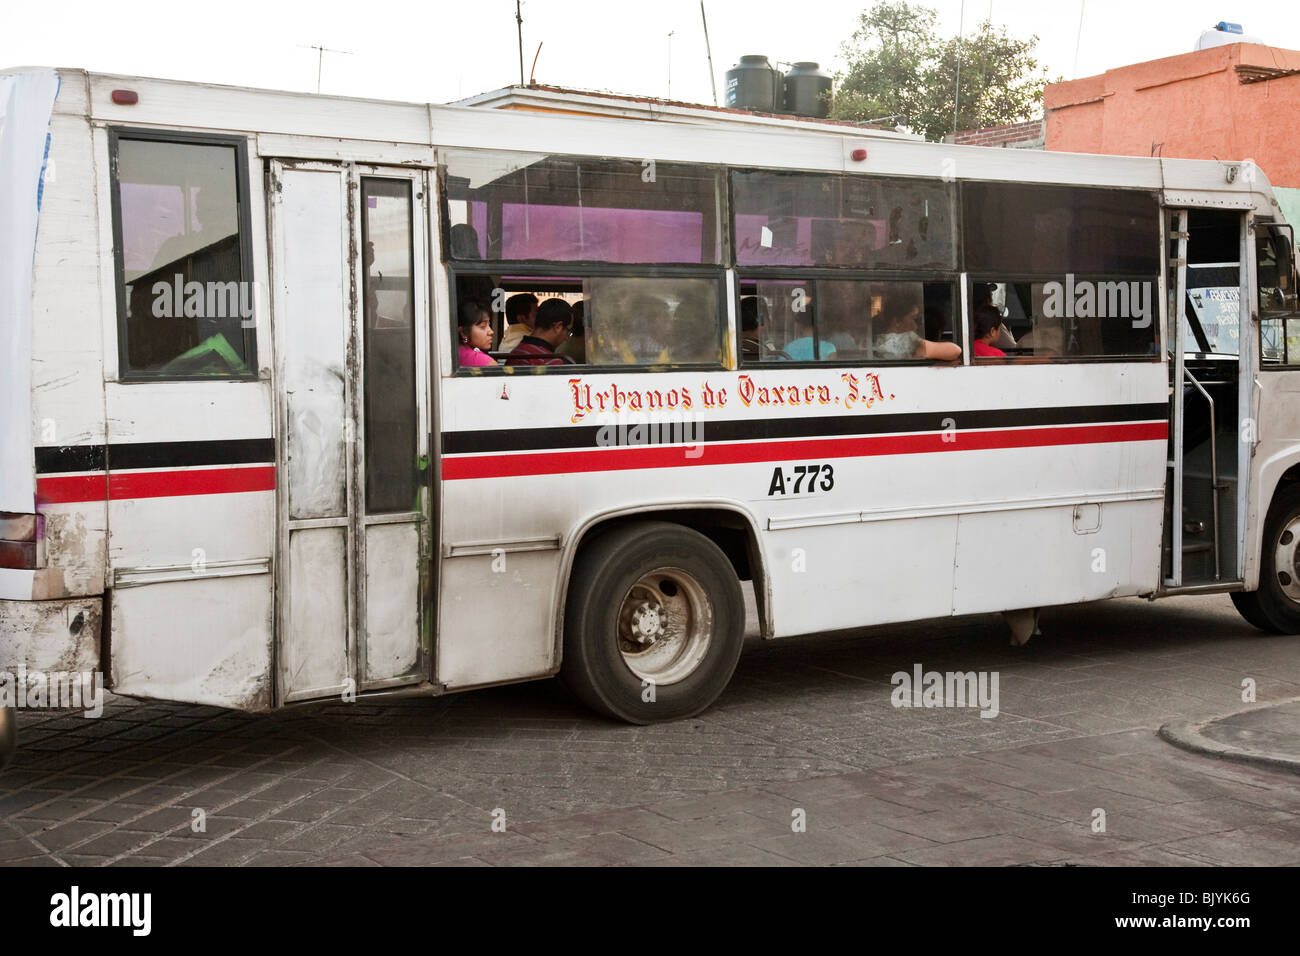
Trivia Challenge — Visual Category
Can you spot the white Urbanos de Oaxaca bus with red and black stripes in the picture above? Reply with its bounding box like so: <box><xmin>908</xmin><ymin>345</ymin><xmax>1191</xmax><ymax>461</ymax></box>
<box><xmin>0</xmin><ymin>70</ymin><xmax>1300</xmax><ymax>754</ymax></box>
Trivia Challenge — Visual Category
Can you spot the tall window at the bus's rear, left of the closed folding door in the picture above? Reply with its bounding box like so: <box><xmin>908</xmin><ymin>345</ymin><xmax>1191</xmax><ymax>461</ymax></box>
<box><xmin>113</xmin><ymin>135</ymin><xmax>256</xmax><ymax>377</ymax></box>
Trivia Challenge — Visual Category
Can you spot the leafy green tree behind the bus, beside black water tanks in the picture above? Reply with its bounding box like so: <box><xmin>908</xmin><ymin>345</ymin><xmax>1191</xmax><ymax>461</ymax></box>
<box><xmin>831</xmin><ymin>0</ymin><xmax>1049</xmax><ymax>139</ymax></box>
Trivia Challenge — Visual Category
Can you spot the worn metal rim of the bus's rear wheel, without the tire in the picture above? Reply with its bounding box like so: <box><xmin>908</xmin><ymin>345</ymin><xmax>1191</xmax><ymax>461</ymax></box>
<box><xmin>618</xmin><ymin>567</ymin><xmax>714</xmax><ymax>687</ymax></box>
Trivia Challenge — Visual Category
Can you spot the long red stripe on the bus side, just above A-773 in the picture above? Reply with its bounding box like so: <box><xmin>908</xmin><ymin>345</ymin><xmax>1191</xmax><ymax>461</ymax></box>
<box><xmin>442</xmin><ymin>421</ymin><xmax>1169</xmax><ymax>481</ymax></box>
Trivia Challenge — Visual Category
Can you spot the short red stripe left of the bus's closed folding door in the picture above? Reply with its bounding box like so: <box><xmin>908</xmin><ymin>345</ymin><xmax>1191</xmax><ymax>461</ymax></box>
<box><xmin>36</xmin><ymin>464</ymin><xmax>276</xmax><ymax>503</ymax></box>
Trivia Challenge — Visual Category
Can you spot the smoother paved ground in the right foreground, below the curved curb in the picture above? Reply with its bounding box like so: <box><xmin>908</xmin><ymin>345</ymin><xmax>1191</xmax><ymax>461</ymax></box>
<box><xmin>322</xmin><ymin>731</ymin><xmax>1300</xmax><ymax>866</ymax></box>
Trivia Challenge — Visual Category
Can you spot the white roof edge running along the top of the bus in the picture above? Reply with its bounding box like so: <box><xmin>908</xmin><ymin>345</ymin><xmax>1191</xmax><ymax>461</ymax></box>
<box><xmin>0</xmin><ymin>68</ymin><xmax>1282</xmax><ymax>220</ymax></box>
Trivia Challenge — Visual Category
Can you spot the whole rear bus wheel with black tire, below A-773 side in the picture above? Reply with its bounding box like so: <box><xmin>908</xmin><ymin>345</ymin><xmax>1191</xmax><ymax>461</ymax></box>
<box><xmin>560</xmin><ymin>522</ymin><xmax>745</xmax><ymax>723</ymax></box>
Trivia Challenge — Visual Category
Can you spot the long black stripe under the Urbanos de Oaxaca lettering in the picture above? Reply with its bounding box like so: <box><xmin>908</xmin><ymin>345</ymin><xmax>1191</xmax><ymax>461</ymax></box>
<box><xmin>442</xmin><ymin>403</ymin><xmax>1169</xmax><ymax>455</ymax></box>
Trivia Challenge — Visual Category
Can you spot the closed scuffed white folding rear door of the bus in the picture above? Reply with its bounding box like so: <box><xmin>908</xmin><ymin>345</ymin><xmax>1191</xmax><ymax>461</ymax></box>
<box><xmin>268</xmin><ymin>161</ymin><xmax>432</xmax><ymax>702</ymax></box>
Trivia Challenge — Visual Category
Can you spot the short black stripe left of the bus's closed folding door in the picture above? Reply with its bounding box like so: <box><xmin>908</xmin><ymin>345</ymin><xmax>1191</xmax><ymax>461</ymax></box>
<box><xmin>36</xmin><ymin>438</ymin><xmax>276</xmax><ymax>475</ymax></box>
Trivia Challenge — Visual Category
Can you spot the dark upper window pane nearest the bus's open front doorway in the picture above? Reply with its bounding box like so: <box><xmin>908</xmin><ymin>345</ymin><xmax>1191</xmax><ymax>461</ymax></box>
<box><xmin>962</xmin><ymin>182</ymin><xmax>1160</xmax><ymax>274</ymax></box>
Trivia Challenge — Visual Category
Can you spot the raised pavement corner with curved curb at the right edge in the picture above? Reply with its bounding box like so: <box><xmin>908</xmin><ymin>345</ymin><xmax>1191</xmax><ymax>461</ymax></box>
<box><xmin>1160</xmin><ymin>698</ymin><xmax>1300</xmax><ymax>774</ymax></box>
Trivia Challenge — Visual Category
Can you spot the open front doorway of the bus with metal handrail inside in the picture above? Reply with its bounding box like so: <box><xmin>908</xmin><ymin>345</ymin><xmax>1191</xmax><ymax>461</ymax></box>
<box><xmin>1162</xmin><ymin>209</ymin><xmax>1253</xmax><ymax>592</ymax></box>
